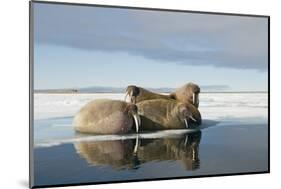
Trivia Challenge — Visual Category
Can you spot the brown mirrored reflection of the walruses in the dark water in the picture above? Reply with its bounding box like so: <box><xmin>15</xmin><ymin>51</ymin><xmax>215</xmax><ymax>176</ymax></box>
<box><xmin>74</xmin><ymin>131</ymin><xmax>201</xmax><ymax>170</ymax></box>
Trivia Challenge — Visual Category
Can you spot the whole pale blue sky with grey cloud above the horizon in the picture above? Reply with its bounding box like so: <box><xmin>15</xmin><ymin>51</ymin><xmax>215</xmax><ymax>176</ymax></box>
<box><xmin>34</xmin><ymin>3</ymin><xmax>268</xmax><ymax>90</ymax></box>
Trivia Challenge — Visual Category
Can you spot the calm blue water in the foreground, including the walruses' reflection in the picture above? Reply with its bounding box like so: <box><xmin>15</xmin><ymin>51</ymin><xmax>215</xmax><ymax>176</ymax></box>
<box><xmin>34</xmin><ymin>117</ymin><xmax>268</xmax><ymax>186</ymax></box>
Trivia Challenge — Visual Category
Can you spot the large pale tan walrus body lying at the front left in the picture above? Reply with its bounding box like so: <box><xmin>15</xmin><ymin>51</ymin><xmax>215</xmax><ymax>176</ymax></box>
<box><xmin>73</xmin><ymin>99</ymin><xmax>137</xmax><ymax>134</ymax></box>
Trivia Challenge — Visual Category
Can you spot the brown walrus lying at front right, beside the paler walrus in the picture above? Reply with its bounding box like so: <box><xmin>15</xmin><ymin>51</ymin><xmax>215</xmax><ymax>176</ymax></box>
<box><xmin>136</xmin><ymin>99</ymin><xmax>201</xmax><ymax>131</ymax></box>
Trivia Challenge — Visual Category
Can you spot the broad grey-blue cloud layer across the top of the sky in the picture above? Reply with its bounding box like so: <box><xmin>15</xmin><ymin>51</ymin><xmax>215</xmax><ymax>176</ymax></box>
<box><xmin>34</xmin><ymin>3</ymin><xmax>268</xmax><ymax>71</ymax></box>
